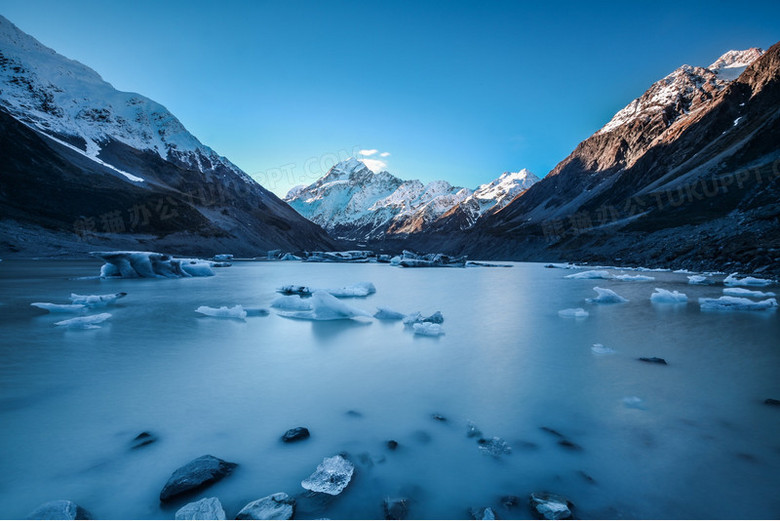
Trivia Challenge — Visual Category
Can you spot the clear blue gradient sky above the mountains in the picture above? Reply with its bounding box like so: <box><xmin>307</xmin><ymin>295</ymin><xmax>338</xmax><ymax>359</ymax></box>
<box><xmin>0</xmin><ymin>0</ymin><xmax>780</xmax><ymax>195</ymax></box>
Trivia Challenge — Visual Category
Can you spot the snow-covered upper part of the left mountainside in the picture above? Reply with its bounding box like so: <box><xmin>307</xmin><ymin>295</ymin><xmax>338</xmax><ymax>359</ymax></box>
<box><xmin>0</xmin><ymin>16</ymin><xmax>249</xmax><ymax>181</ymax></box>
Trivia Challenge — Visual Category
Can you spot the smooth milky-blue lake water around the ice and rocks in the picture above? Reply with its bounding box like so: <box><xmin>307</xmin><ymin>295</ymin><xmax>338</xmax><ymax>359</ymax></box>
<box><xmin>0</xmin><ymin>261</ymin><xmax>780</xmax><ymax>519</ymax></box>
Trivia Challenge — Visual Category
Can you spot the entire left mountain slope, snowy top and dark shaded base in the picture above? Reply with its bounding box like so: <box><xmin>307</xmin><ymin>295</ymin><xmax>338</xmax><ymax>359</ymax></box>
<box><xmin>0</xmin><ymin>16</ymin><xmax>332</xmax><ymax>255</ymax></box>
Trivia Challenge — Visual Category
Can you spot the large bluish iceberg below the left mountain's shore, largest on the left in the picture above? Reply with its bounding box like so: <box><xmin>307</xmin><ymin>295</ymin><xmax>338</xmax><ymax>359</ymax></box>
<box><xmin>91</xmin><ymin>251</ymin><xmax>214</xmax><ymax>278</ymax></box>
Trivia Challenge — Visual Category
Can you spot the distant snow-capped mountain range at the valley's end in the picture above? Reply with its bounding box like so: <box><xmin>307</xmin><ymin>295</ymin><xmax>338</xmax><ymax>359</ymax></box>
<box><xmin>285</xmin><ymin>158</ymin><xmax>539</xmax><ymax>240</ymax></box>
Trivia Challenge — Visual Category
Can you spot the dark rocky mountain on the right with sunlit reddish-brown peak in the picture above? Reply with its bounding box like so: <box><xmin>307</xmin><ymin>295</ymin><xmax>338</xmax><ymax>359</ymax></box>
<box><xmin>458</xmin><ymin>45</ymin><xmax>780</xmax><ymax>269</ymax></box>
